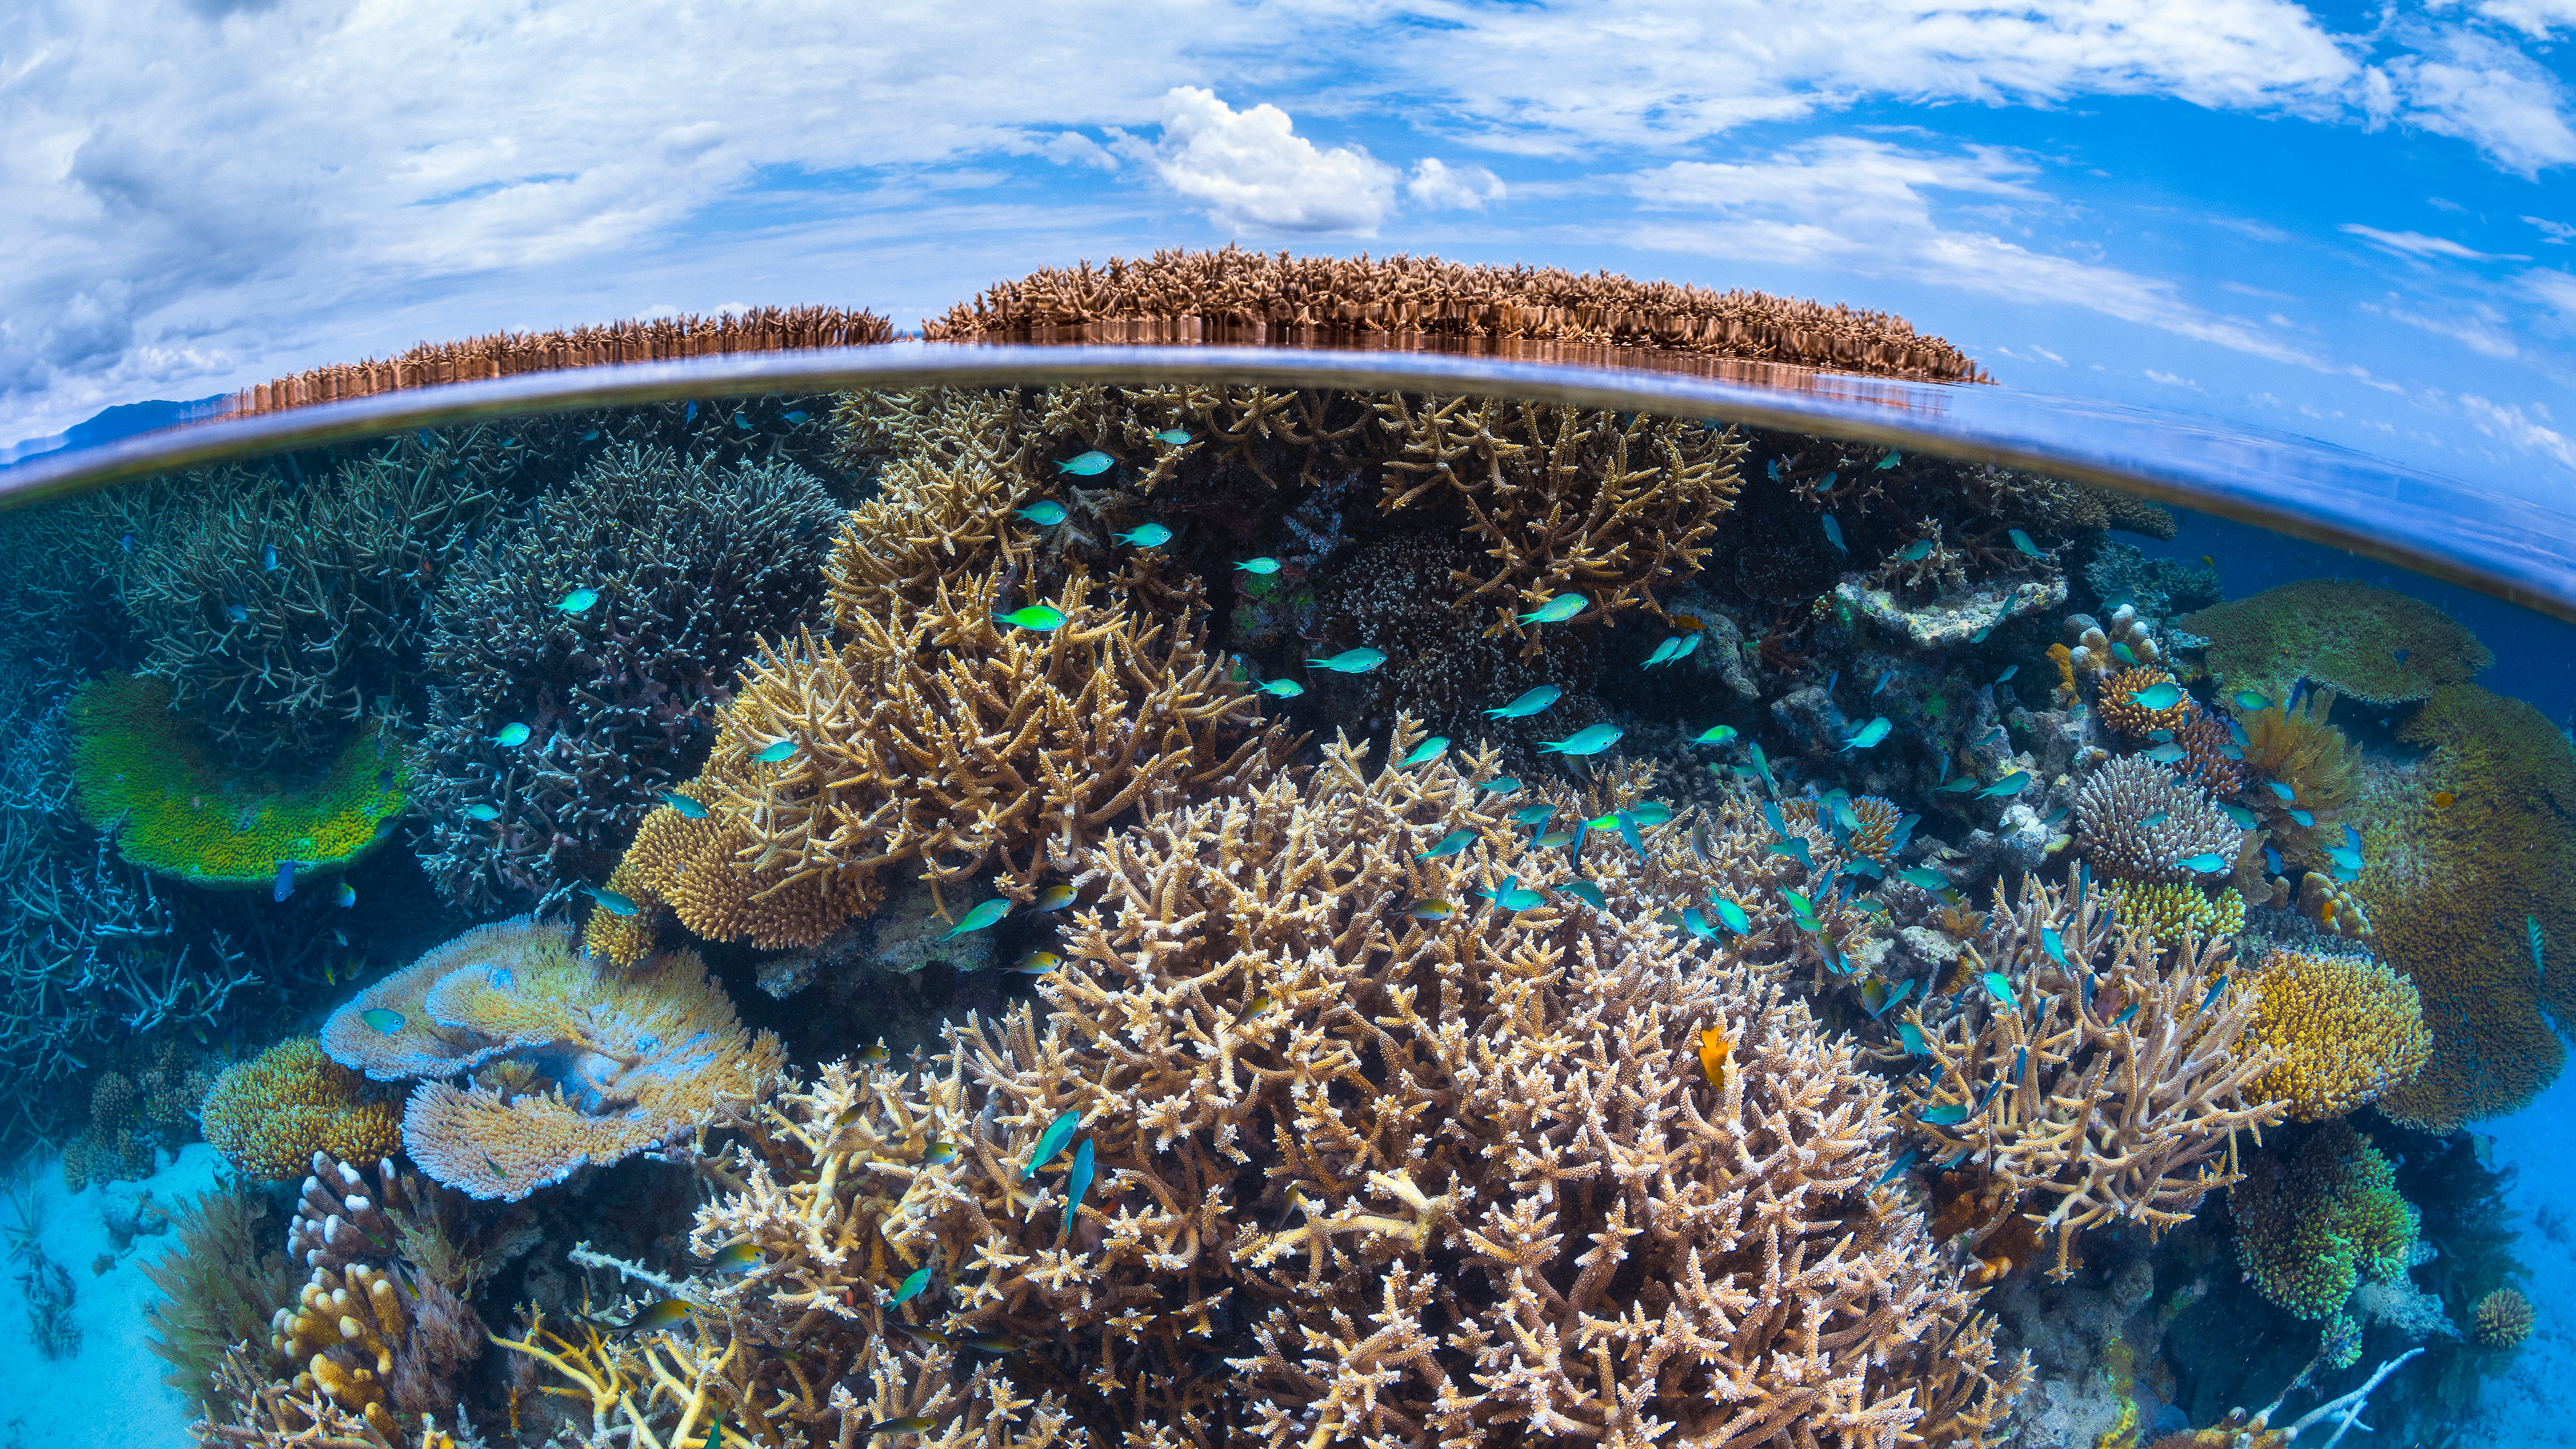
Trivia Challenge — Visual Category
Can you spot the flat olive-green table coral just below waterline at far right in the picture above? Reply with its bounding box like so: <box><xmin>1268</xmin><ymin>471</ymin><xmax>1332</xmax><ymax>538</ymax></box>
<box><xmin>2180</xmin><ymin>578</ymin><xmax>2496</xmax><ymax>706</ymax></box>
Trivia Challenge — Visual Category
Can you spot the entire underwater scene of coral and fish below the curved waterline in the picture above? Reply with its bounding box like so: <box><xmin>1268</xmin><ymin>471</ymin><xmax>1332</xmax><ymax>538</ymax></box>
<box><xmin>0</xmin><ymin>363</ymin><xmax>2576</xmax><ymax>1449</ymax></box>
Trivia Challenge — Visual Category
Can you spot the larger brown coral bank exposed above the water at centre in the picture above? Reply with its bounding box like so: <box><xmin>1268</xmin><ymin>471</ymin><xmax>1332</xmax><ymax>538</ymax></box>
<box><xmin>922</xmin><ymin>245</ymin><xmax>1984</xmax><ymax>382</ymax></box>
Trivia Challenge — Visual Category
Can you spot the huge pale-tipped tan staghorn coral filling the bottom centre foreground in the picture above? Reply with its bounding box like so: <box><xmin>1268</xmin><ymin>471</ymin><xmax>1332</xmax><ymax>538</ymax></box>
<box><xmin>549</xmin><ymin>719</ymin><xmax>2022</xmax><ymax>1446</ymax></box>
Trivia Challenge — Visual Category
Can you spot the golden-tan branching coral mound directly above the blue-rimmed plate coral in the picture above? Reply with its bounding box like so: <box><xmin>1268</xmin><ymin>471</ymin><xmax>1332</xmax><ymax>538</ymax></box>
<box><xmin>588</xmin><ymin>564</ymin><xmax>1288</xmax><ymax>959</ymax></box>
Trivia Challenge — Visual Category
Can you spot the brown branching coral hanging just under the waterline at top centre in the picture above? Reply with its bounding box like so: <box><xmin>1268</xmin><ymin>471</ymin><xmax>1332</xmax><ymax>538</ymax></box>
<box><xmin>1378</xmin><ymin>394</ymin><xmax>1744</xmax><ymax>652</ymax></box>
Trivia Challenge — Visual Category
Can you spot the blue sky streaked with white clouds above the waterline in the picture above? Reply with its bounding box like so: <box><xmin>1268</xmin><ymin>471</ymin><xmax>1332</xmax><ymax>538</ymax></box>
<box><xmin>0</xmin><ymin>0</ymin><xmax>2576</xmax><ymax>492</ymax></box>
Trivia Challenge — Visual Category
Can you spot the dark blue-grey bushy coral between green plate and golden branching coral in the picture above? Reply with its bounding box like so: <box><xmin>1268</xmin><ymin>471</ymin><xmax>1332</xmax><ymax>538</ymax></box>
<box><xmin>417</xmin><ymin>443</ymin><xmax>843</xmax><ymax>910</ymax></box>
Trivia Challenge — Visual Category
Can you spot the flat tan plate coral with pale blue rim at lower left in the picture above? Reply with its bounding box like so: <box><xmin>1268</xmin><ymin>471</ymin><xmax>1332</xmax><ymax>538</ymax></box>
<box><xmin>327</xmin><ymin>920</ymin><xmax>786</xmax><ymax>1201</ymax></box>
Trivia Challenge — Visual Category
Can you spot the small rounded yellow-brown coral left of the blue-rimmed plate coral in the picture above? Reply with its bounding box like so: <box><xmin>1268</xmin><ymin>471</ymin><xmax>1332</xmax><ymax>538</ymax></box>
<box><xmin>203</xmin><ymin>1036</ymin><xmax>399</xmax><ymax>1181</ymax></box>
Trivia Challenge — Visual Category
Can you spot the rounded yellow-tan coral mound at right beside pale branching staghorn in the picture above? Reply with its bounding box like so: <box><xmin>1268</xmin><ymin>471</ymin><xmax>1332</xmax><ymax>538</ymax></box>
<box><xmin>2246</xmin><ymin>951</ymin><xmax>2432</xmax><ymax>1122</ymax></box>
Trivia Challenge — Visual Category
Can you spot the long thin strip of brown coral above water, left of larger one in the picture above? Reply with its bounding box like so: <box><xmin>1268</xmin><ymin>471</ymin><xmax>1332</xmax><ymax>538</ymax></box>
<box><xmin>227</xmin><ymin>307</ymin><xmax>894</xmax><ymax>415</ymax></box>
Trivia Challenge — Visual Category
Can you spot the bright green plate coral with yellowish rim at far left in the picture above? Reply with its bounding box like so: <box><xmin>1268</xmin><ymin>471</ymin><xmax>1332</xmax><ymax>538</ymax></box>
<box><xmin>70</xmin><ymin>673</ymin><xmax>410</xmax><ymax>890</ymax></box>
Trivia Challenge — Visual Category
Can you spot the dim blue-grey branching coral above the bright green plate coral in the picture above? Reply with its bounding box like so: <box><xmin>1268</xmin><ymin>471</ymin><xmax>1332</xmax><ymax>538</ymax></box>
<box><xmin>126</xmin><ymin>433</ymin><xmax>500</xmax><ymax>758</ymax></box>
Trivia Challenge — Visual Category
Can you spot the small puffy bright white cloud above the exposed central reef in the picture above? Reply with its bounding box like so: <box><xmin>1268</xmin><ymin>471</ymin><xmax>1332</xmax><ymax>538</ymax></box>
<box><xmin>1134</xmin><ymin>85</ymin><xmax>1396</xmax><ymax>237</ymax></box>
